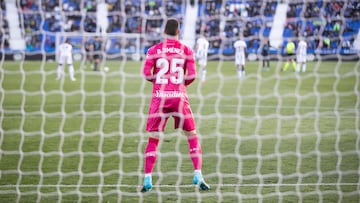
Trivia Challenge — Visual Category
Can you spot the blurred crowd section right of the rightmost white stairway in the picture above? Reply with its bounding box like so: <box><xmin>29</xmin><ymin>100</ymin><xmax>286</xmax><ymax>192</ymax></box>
<box><xmin>284</xmin><ymin>0</ymin><xmax>360</xmax><ymax>52</ymax></box>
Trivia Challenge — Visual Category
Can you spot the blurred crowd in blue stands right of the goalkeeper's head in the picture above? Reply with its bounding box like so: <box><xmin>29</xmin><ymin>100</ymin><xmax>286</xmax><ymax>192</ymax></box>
<box><xmin>197</xmin><ymin>0</ymin><xmax>360</xmax><ymax>53</ymax></box>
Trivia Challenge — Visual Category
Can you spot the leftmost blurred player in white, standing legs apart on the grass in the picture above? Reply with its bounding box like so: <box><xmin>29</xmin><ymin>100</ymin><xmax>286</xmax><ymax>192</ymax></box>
<box><xmin>56</xmin><ymin>39</ymin><xmax>76</xmax><ymax>81</ymax></box>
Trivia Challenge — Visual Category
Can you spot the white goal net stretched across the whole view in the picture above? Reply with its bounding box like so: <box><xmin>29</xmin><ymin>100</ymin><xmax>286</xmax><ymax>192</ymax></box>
<box><xmin>0</xmin><ymin>0</ymin><xmax>360</xmax><ymax>202</ymax></box>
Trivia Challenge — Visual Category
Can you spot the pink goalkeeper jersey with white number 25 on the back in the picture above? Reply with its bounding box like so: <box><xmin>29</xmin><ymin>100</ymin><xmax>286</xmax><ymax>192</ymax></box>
<box><xmin>143</xmin><ymin>38</ymin><xmax>196</xmax><ymax>98</ymax></box>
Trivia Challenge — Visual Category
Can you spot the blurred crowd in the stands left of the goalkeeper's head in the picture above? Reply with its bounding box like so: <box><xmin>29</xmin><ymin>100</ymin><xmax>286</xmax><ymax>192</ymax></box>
<box><xmin>1</xmin><ymin>0</ymin><xmax>184</xmax><ymax>52</ymax></box>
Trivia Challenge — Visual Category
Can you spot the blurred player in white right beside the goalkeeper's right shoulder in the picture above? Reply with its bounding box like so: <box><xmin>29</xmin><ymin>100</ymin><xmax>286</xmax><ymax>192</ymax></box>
<box><xmin>195</xmin><ymin>35</ymin><xmax>209</xmax><ymax>83</ymax></box>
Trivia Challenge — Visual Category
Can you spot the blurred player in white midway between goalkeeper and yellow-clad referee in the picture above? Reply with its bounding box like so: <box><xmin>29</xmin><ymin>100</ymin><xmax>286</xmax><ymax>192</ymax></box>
<box><xmin>234</xmin><ymin>36</ymin><xmax>247</xmax><ymax>78</ymax></box>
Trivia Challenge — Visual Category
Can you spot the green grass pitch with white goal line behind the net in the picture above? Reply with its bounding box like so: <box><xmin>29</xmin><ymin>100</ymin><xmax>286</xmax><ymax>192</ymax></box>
<box><xmin>0</xmin><ymin>58</ymin><xmax>360</xmax><ymax>202</ymax></box>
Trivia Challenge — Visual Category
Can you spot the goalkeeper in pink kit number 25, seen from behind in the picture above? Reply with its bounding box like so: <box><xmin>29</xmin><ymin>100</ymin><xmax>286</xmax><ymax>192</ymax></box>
<box><xmin>141</xmin><ymin>18</ymin><xmax>210</xmax><ymax>192</ymax></box>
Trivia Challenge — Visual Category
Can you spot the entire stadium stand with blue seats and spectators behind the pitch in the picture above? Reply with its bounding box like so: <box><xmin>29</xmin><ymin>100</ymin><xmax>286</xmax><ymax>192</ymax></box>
<box><xmin>0</xmin><ymin>0</ymin><xmax>360</xmax><ymax>59</ymax></box>
